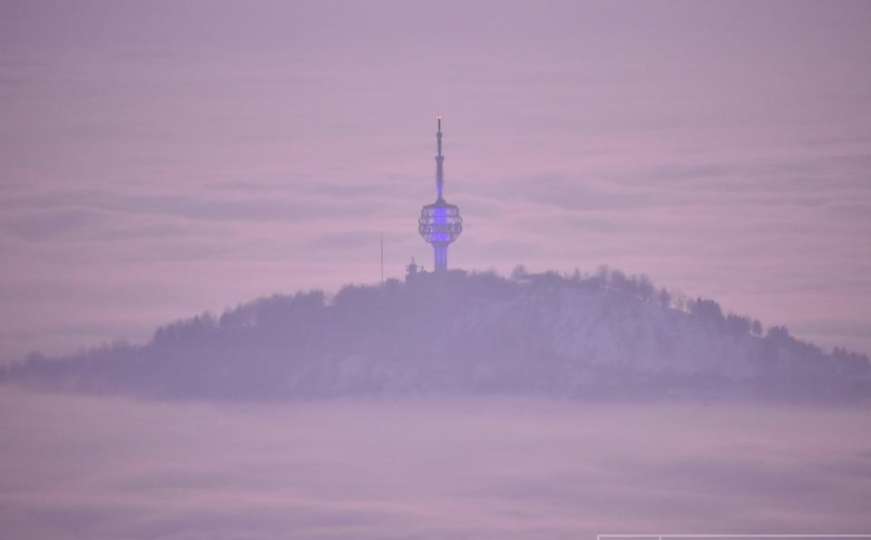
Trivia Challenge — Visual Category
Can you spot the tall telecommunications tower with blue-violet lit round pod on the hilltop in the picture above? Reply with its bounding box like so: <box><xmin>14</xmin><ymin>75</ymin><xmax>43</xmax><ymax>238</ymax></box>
<box><xmin>417</xmin><ymin>117</ymin><xmax>463</xmax><ymax>272</ymax></box>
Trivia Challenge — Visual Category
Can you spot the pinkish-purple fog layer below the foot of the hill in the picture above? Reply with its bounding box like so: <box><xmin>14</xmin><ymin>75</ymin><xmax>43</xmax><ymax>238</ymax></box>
<box><xmin>0</xmin><ymin>389</ymin><xmax>871</xmax><ymax>540</ymax></box>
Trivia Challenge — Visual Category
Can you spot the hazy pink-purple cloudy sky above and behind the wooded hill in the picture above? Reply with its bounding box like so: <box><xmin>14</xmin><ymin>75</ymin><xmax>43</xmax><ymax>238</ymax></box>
<box><xmin>0</xmin><ymin>0</ymin><xmax>871</xmax><ymax>361</ymax></box>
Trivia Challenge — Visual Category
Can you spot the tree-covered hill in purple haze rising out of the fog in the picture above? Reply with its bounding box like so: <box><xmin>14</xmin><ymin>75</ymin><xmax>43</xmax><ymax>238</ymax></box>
<box><xmin>3</xmin><ymin>267</ymin><xmax>871</xmax><ymax>400</ymax></box>
